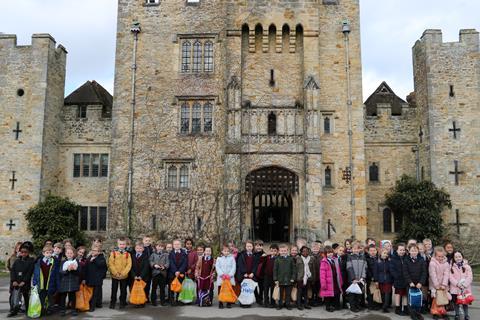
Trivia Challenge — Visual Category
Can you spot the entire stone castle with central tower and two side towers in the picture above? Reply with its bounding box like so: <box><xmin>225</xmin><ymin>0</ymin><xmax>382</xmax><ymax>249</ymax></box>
<box><xmin>0</xmin><ymin>0</ymin><xmax>480</xmax><ymax>257</ymax></box>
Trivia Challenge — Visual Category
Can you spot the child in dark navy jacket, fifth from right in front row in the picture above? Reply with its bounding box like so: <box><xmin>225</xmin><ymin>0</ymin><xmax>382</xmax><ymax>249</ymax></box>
<box><xmin>375</xmin><ymin>248</ymin><xmax>393</xmax><ymax>313</ymax></box>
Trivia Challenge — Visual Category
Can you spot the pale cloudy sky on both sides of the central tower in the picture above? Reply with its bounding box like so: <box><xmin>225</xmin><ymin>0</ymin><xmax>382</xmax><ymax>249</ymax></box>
<box><xmin>0</xmin><ymin>0</ymin><xmax>480</xmax><ymax>100</ymax></box>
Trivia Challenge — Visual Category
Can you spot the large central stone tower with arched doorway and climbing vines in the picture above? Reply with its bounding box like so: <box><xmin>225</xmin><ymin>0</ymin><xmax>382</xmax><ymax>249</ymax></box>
<box><xmin>109</xmin><ymin>0</ymin><xmax>366</xmax><ymax>241</ymax></box>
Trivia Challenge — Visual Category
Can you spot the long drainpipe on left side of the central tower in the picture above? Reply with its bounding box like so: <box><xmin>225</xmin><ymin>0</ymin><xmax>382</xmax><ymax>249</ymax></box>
<box><xmin>127</xmin><ymin>22</ymin><xmax>141</xmax><ymax>236</ymax></box>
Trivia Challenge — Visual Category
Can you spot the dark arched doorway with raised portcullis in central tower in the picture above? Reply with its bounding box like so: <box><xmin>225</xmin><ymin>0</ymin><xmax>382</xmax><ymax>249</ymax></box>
<box><xmin>245</xmin><ymin>167</ymin><xmax>298</xmax><ymax>242</ymax></box>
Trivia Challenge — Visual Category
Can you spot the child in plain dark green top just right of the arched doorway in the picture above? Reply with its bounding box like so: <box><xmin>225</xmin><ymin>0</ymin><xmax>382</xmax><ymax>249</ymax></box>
<box><xmin>273</xmin><ymin>244</ymin><xmax>297</xmax><ymax>310</ymax></box>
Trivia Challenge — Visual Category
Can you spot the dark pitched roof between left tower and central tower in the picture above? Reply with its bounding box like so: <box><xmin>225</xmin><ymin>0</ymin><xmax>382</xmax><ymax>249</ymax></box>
<box><xmin>64</xmin><ymin>80</ymin><xmax>113</xmax><ymax>107</ymax></box>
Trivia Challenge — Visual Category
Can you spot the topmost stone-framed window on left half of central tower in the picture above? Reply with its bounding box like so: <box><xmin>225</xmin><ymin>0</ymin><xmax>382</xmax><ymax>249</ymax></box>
<box><xmin>178</xmin><ymin>33</ymin><xmax>218</xmax><ymax>75</ymax></box>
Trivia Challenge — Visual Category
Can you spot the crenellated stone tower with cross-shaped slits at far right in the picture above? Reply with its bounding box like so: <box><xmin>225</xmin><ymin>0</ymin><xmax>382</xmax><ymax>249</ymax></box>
<box><xmin>413</xmin><ymin>29</ymin><xmax>480</xmax><ymax>237</ymax></box>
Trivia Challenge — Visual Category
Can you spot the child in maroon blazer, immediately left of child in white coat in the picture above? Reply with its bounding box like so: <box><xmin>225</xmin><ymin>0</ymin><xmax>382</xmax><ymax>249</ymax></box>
<box><xmin>195</xmin><ymin>246</ymin><xmax>215</xmax><ymax>307</ymax></box>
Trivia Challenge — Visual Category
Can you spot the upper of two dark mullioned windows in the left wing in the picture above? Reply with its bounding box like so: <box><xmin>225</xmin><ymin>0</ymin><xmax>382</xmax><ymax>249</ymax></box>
<box><xmin>72</xmin><ymin>153</ymin><xmax>110</xmax><ymax>179</ymax></box>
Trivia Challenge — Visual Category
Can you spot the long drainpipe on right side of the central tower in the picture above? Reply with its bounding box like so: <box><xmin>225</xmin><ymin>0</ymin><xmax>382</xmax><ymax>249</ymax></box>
<box><xmin>342</xmin><ymin>20</ymin><xmax>356</xmax><ymax>239</ymax></box>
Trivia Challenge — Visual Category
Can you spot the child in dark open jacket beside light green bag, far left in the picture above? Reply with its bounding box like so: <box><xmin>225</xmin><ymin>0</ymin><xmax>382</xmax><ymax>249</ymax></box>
<box><xmin>33</xmin><ymin>246</ymin><xmax>60</xmax><ymax>315</ymax></box>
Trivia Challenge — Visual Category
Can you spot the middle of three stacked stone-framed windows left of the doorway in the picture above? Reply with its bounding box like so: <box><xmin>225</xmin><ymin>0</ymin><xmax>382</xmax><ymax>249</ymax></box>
<box><xmin>177</xmin><ymin>96</ymin><xmax>216</xmax><ymax>136</ymax></box>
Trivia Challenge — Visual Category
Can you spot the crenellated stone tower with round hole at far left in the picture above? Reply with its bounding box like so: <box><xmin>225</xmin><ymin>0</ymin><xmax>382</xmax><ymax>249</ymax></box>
<box><xmin>0</xmin><ymin>34</ymin><xmax>67</xmax><ymax>255</ymax></box>
